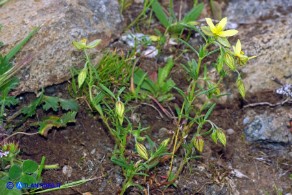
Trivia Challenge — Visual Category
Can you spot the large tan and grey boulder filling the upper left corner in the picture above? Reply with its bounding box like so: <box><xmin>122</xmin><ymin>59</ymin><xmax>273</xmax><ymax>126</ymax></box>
<box><xmin>0</xmin><ymin>0</ymin><xmax>123</xmax><ymax>93</ymax></box>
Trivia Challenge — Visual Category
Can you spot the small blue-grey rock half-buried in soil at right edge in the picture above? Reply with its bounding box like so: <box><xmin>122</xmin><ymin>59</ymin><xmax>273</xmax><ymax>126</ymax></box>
<box><xmin>244</xmin><ymin>107</ymin><xmax>292</xmax><ymax>145</ymax></box>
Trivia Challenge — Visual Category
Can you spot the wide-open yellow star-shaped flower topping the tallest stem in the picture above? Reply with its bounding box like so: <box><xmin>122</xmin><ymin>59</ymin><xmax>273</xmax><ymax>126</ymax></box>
<box><xmin>202</xmin><ymin>17</ymin><xmax>238</xmax><ymax>38</ymax></box>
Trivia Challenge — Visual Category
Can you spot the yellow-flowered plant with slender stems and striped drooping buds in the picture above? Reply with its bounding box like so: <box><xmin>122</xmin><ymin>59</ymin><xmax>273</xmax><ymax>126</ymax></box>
<box><xmin>74</xmin><ymin>15</ymin><xmax>254</xmax><ymax>194</ymax></box>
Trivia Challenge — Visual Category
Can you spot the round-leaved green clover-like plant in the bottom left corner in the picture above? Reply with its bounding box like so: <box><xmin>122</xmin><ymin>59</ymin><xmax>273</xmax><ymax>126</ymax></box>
<box><xmin>0</xmin><ymin>142</ymin><xmax>95</xmax><ymax>195</ymax></box>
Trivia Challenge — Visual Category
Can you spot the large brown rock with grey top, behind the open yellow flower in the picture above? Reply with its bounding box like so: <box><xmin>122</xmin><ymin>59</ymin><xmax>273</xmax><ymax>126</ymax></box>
<box><xmin>225</xmin><ymin>0</ymin><xmax>292</xmax><ymax>93</ymax></box>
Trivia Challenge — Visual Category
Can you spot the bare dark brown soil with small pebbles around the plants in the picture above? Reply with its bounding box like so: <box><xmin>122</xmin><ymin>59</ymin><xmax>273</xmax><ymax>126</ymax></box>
<box><xmin>10</xmin><ymin>0</ymin><xmax>292</xmax><ymax>195</ymax></box>
